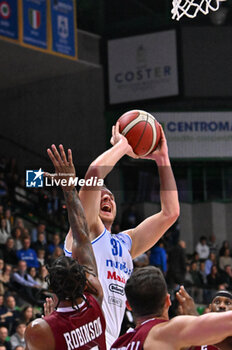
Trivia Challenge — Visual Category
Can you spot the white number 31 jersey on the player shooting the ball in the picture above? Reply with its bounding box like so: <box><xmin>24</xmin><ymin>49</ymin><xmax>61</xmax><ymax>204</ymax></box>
<box><xmin>64</xmin><ymin>229</ymin><xmax>133</xmax><ymax>349</ymax></box>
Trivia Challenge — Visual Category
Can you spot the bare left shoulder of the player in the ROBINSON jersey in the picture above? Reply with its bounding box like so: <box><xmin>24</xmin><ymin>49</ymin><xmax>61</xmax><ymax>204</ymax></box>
<box><xmin>25</xmin><ymin>318</ymin><xmax>55</xmax><ymax>350</ymax></box>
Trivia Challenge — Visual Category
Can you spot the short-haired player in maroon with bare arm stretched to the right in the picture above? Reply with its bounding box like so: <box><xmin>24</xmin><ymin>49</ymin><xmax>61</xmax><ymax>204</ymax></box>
<box><xmin>111</xmin><ymin>266</ymin><xmax>232</xmax><ymax>350</ymax></box>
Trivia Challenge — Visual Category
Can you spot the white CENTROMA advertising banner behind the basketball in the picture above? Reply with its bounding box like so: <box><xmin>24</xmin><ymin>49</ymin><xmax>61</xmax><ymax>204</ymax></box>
<box><xmin>155</xmin><ymin>112</ymin><xmax>232</xmax><ymax>159</ymax></box>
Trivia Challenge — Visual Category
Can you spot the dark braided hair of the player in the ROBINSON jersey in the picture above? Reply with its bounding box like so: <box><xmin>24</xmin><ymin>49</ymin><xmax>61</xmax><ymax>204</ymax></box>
<box><xmin>46</xmin><ymin>256</ymin><xmax>86</xmax><ymax>307</ymax></box>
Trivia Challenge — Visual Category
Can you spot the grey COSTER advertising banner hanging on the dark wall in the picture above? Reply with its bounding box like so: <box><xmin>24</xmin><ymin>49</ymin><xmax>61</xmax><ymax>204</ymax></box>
<box><xmin>108</xmin><ymin>30</ymin><xmax>178</xmax><ymax>104</ymax></box>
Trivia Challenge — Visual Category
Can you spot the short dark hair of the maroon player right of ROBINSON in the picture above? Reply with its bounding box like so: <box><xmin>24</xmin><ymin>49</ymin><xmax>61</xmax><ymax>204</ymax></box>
<box><xmin>125</xmin><ymin>266</ymin><xmax>167</xmax><ymax>317</ymax></box>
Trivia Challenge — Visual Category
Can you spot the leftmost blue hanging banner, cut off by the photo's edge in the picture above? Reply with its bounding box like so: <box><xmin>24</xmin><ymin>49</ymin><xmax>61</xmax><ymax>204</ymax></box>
<box><xmin>0</xmin><ymin>0</ymin><xmax>18</xmax><ymax>40</ymax></box>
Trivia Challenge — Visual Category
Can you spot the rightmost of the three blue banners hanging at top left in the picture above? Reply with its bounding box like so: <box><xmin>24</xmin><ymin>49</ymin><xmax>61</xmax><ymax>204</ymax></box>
<box><xmin>51</xmin><ymin>0</ymin><xmax>76</xmax><ymax>57</ymax></box>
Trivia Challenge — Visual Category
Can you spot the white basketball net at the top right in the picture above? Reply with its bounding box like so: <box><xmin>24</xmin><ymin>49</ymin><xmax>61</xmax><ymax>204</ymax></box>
<box><xmin>171</xmin><ymin>0</ymin><xmax>226</xmax><ymax>21</ymax></box>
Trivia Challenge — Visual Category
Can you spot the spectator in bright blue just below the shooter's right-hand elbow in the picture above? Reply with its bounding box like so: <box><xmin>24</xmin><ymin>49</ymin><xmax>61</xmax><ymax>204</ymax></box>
<box><xmin>150</xmin><ymin>239</ymin><xmax>167</xmax><ymax>275</ymax></box>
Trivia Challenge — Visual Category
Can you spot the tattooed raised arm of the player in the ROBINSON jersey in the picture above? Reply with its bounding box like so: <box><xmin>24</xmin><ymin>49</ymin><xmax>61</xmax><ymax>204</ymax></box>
<box><xmin>48</xmin><ymin>145</ymin><xmax>102</xmax><ymax>299</ymax></box>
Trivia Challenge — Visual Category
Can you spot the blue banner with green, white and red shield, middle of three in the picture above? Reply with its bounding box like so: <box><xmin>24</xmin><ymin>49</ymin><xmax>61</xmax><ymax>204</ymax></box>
<box><xmin>23</xmin><ymin>0</ymin><xmax>48</xmax><ymax>49</ymax></box>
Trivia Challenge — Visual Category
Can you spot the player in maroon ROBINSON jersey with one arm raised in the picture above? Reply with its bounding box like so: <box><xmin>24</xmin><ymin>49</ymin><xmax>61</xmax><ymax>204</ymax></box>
<box><xmin>25</xmin><ymin>145</ymin><xmax>106</xmax><ymax>350</ymax></box>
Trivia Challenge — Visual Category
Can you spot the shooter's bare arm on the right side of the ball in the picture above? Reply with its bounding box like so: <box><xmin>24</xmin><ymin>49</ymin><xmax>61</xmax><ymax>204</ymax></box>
<box><xmin>129</xmin><ymin>126</ymin><xmax>180</xmax><ymax>258</ymax></box>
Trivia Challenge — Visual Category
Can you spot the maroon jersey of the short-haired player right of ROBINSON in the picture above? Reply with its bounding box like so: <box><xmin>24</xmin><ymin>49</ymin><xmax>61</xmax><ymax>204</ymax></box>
<box><xmin>111</xmin><ymin>318</ymin><xmax>166</xmax><ymax>350</ymax></box>
